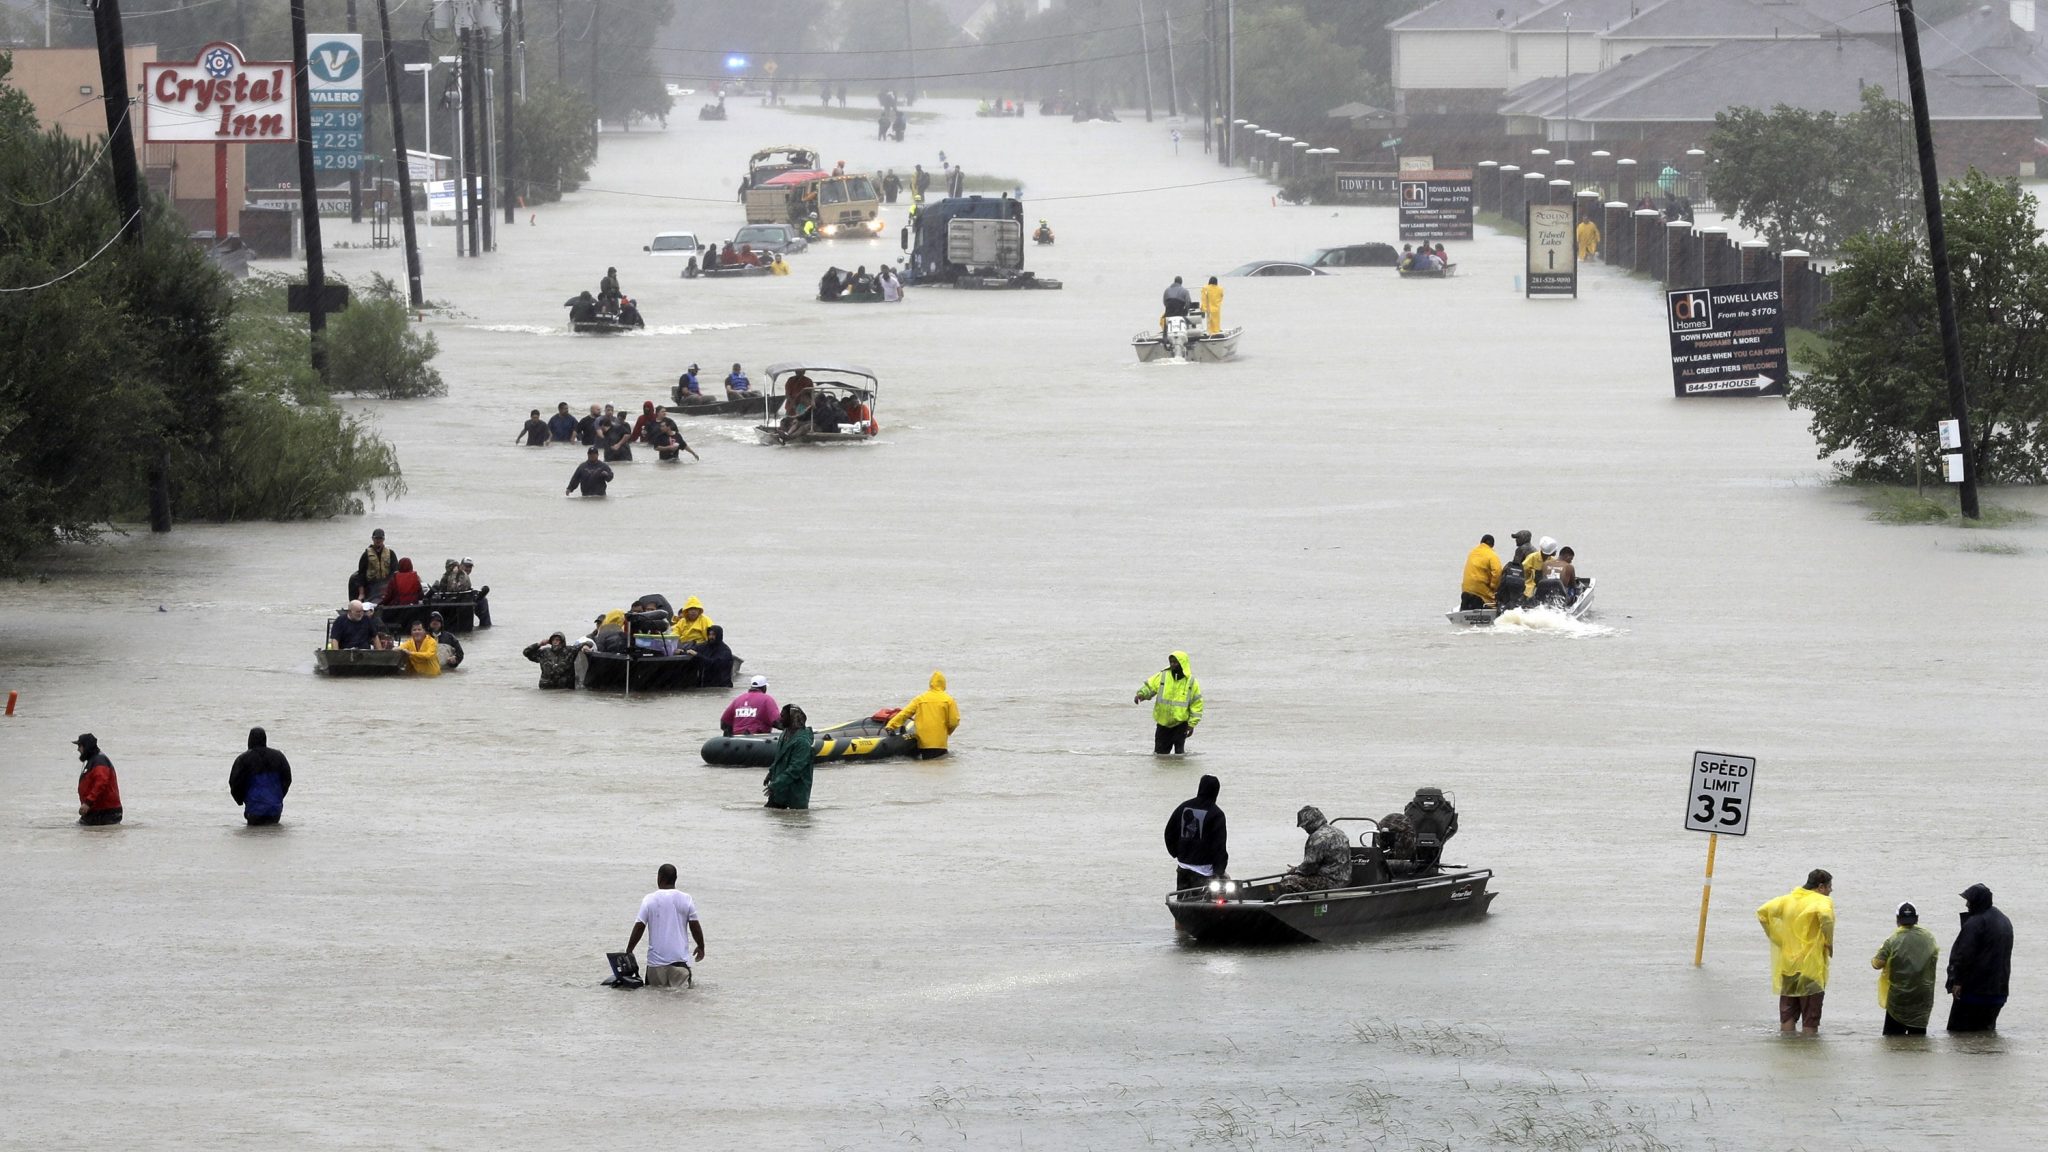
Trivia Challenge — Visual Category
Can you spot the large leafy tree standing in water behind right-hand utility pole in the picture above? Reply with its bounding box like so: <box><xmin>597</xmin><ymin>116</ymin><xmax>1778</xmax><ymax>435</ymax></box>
<box><xmin>1788</xmin><ymin>170</ymin><xmax>2048</xmax><ymax>484</ymax></box>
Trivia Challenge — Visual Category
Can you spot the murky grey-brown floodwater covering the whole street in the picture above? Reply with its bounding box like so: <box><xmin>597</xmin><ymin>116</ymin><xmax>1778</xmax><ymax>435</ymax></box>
<box><xmin>0</xmin><ymin>102</ymin><xmax>2048</xmax><ymax>1150</ymax></box>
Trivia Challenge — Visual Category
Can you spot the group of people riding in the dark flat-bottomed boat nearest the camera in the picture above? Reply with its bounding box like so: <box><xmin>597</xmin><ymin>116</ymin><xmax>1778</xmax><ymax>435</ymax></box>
<box><xmin>1165</xmin><ymin>777</ymin><xmax>1458</xmax><ymax>894</ymax></box>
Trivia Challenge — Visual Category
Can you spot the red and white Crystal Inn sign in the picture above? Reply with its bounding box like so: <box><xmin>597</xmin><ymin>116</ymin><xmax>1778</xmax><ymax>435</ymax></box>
<box><xmin>141</xmin><ymin>41</ymin><xmax>299</xmax><ymax>143</ymax></box>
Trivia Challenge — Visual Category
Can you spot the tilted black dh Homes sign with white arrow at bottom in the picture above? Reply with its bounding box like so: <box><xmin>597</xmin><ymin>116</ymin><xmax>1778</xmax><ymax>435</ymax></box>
<box><xmin>1665</xmin><ymin>281</ymin><xmax>1788</xmax><ymax>398</ymax></box>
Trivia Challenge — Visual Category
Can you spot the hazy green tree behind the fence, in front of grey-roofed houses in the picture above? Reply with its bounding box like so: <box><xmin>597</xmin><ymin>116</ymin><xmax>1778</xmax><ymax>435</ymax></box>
<box><xmin>1706</xmin><ymin>86</ymin><xmax>1919</xmax><ymax>252</ymax></box>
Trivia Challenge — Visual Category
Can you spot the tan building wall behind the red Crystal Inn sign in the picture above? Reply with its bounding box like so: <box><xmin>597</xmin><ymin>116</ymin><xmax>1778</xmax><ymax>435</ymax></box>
<box><xmin>10</xmin><ymin>43</ymin><xmax>248</xmax><ymax>232</ymax></box>
